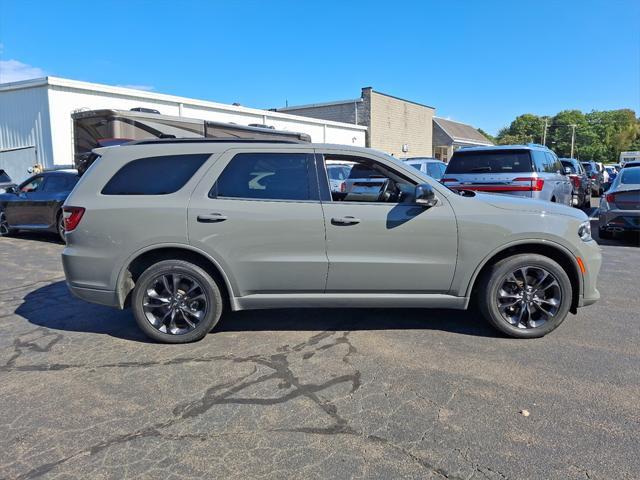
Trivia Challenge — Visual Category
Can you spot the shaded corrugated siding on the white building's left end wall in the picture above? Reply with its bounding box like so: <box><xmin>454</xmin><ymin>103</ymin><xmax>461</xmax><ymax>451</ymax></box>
<box><xmin>0</xmin><ymin>86</ymin><xmax>53</xmax><ymax>167</ymax></box>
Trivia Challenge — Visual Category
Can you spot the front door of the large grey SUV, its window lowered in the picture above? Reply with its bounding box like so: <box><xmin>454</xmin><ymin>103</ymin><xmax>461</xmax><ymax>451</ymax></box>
<box><xmin>319</xmin><ymin>152</ymin><xmax>458</xmax><ymax>293</ymax></box>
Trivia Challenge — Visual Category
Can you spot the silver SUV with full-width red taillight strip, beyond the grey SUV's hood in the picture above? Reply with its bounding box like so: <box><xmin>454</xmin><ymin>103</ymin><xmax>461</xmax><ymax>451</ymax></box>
<box><xmin>442</xmin><ymin>144</ymin><xmax>573</xmax><ymax>205</ymax></box>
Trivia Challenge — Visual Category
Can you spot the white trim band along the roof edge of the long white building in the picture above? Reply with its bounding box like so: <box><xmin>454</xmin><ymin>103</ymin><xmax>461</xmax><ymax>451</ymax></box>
<box><xmin>0</xmin><ymin>77</ymin><xmax>367</xmax><ymax>131</ymax></box>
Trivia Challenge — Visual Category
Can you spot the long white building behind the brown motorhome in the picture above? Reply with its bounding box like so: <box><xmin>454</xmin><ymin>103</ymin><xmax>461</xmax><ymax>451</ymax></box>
<box><xmin>0</xmin><ymin>77</ymin><xmax>367</xmax><ymax>180</ymax></box>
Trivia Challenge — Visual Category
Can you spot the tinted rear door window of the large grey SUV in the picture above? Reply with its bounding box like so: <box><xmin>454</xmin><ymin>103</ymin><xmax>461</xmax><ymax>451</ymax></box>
<box><xmin>210</xmin><ymin>153</ymin><xmax>313</xmax><ymax>200</ymax></box>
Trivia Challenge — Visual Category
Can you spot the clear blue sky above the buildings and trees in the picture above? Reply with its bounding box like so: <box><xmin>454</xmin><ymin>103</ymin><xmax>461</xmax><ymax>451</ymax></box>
<box><xmin>0</xmin><ymin>0</ymin><xmax>640</xmax><ymax>133</ymax></box>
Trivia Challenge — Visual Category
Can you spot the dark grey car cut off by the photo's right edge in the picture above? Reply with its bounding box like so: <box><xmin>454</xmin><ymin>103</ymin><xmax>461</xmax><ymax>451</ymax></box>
<box><xmin>598</xmin><ymin>166</ymin><xmax>640</xmax><ymax>238</ymax></box>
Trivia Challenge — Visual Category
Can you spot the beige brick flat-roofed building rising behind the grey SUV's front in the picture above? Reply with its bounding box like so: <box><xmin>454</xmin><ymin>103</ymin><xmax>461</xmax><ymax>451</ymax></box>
<box><xmin>274</xmin><ymin>87</ymin><xmax>435</xmax><ymax>157</ymax></box>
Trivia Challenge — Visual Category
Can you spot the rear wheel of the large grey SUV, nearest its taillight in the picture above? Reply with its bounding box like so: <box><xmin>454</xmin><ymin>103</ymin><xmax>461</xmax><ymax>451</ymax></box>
<box><xmin>131</xmin><ymin>260</ymin><xmax>223</xmax><ymax>343</ymax></box>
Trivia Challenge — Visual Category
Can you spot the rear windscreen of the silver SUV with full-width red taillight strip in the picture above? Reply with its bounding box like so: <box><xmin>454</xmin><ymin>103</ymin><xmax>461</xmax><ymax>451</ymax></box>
<box><xmin>447</xmin><ymin>150</ymin><xmax>532</xmax><ymax>174</ymax></box>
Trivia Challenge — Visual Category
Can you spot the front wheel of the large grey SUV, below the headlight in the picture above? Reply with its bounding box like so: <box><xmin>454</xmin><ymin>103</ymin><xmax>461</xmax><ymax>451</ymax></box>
<box><xmin>478</xmin><ymin>254</ymin><xmax>572</xmax><ymax>338</ymax></box>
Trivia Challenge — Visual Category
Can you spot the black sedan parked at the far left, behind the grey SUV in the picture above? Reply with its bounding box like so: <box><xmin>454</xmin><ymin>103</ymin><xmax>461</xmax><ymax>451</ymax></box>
<box><xmin>0</xmin><ymin>170</ymin><xmax>79</xmax><ymax>241</ymax></box>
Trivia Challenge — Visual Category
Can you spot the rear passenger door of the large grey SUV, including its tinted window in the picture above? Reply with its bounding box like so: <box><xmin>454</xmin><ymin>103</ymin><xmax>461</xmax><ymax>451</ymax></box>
<box><xmin>188</xmin><ymin>147</ymin><xmax>328</xmax><ymax>296</ymax></box>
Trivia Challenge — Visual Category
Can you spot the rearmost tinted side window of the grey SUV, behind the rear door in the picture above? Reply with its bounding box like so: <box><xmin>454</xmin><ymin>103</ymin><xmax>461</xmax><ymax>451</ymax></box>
<box><xmin>102</xmin><ymin>153</ymin><xmax>210</xmax><ymax>195</ymax></box>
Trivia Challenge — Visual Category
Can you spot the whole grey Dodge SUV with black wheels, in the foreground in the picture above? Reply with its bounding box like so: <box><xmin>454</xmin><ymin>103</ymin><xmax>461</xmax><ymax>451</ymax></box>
<box><xmin>62</xmin><ymin>139</ymin><xmax>601</xmax><ymax>343</ymax></box>
